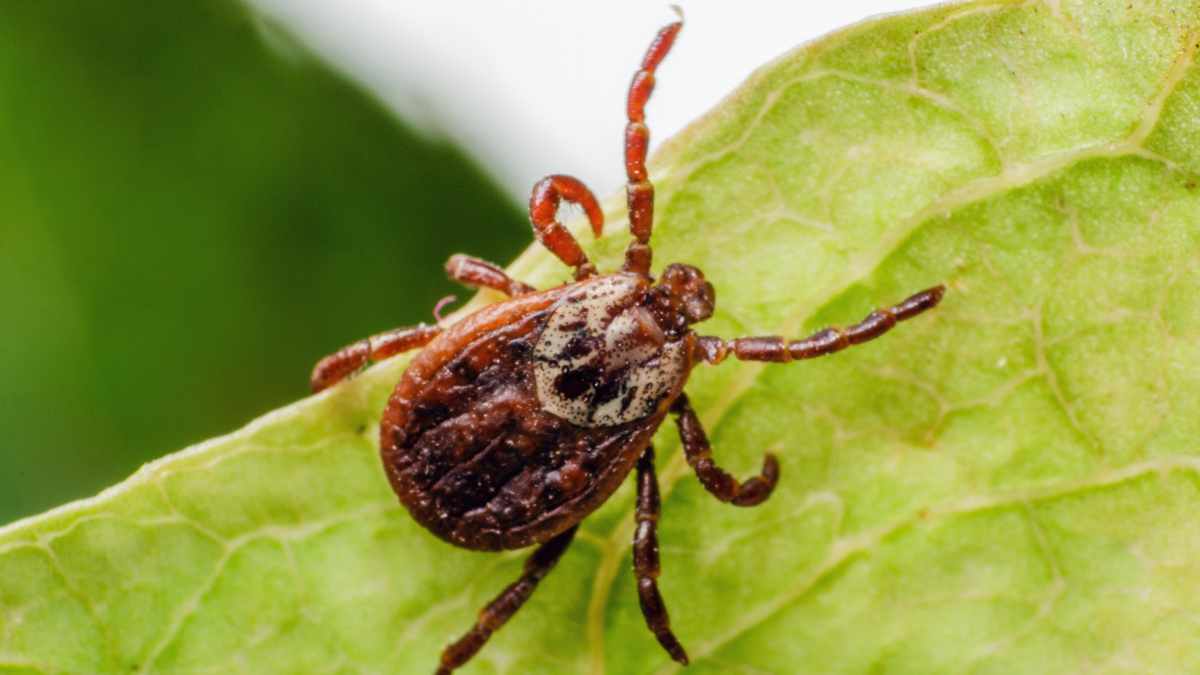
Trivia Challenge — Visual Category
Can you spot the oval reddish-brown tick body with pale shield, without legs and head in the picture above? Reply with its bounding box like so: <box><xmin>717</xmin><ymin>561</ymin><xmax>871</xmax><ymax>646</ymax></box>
<box><xmin>382</xmin><ymin>276</ymin><xmax>688</xmax><ymax>551</ymax></box>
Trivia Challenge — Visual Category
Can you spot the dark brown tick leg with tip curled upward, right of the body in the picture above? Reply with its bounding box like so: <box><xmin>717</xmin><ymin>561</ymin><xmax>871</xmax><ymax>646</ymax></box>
<box><xmin>671</xmin><ymin>394</ymin><xmax>779</xmax><ymax>506</ymax></box>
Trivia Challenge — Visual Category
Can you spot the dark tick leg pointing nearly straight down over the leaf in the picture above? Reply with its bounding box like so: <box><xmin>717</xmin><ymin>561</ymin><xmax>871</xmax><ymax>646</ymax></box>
<box><xmin>634</xmin><ymin>446</ymin><xmax>688</xmax><ymax>665</ymax></box>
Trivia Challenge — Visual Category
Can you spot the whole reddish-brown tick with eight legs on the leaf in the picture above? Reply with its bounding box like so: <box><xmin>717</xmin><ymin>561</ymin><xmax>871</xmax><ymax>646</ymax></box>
<box><xmin>312</xmin><ymin>17</ymin><xmax>944</xmax><ymax>675</ymax></box>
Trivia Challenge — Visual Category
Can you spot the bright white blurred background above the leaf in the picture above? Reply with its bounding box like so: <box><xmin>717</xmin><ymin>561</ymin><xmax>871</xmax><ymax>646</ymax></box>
<box><xmin>251</xmin><ymin>0</ymin><xmax>931</xmax><ymax>202</ymax></box>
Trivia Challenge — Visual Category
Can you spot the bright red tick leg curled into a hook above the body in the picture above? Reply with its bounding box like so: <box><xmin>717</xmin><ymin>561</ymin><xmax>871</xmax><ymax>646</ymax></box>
<box><xmin>529</xmin><ymin>175</ymin><xmax>604</xmax><ymax>281</ymax></box>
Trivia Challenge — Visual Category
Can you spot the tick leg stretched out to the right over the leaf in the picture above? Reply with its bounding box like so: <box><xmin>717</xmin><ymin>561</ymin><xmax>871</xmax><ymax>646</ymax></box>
<box><xmin>696</xmin><ymin>286</ymin><xmax>946</xmax><ymax>364</ymax></box>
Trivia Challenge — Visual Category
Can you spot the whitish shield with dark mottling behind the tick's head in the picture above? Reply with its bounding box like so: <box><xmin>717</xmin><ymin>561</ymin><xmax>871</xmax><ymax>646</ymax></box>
<box><xmin>534</xmin><ymin>275</ymin><xmax>688</xmax><ymax>428</ymax></box>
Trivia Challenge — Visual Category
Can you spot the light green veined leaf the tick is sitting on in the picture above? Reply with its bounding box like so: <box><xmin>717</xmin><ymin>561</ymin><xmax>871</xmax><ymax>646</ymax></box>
<box><xmin>0</xmin><ymin>0</ymin><xmax>1200</xmax><ymax>674</ymax></box>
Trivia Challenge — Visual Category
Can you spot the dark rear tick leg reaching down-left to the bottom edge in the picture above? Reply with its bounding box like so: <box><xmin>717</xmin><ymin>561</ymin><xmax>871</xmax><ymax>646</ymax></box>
<box><xmin>436</xmin><ymin>525</ymin><xmax>578</xmax><ymax>675</ymax></box>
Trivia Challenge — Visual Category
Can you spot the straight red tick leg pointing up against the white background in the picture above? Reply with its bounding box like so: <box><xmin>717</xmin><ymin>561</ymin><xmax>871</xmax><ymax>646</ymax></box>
<box><xmin>622</xmin><ymin>22</ymin><xmax>683</xmax><ymax>275</ymax></box>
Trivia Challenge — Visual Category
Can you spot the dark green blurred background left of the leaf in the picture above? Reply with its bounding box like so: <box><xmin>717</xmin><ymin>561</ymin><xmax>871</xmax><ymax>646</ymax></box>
<box><xmin>0</xmin><ymin>0</ymin><xmax>532</xmax><ymax>524</ymax></box>
